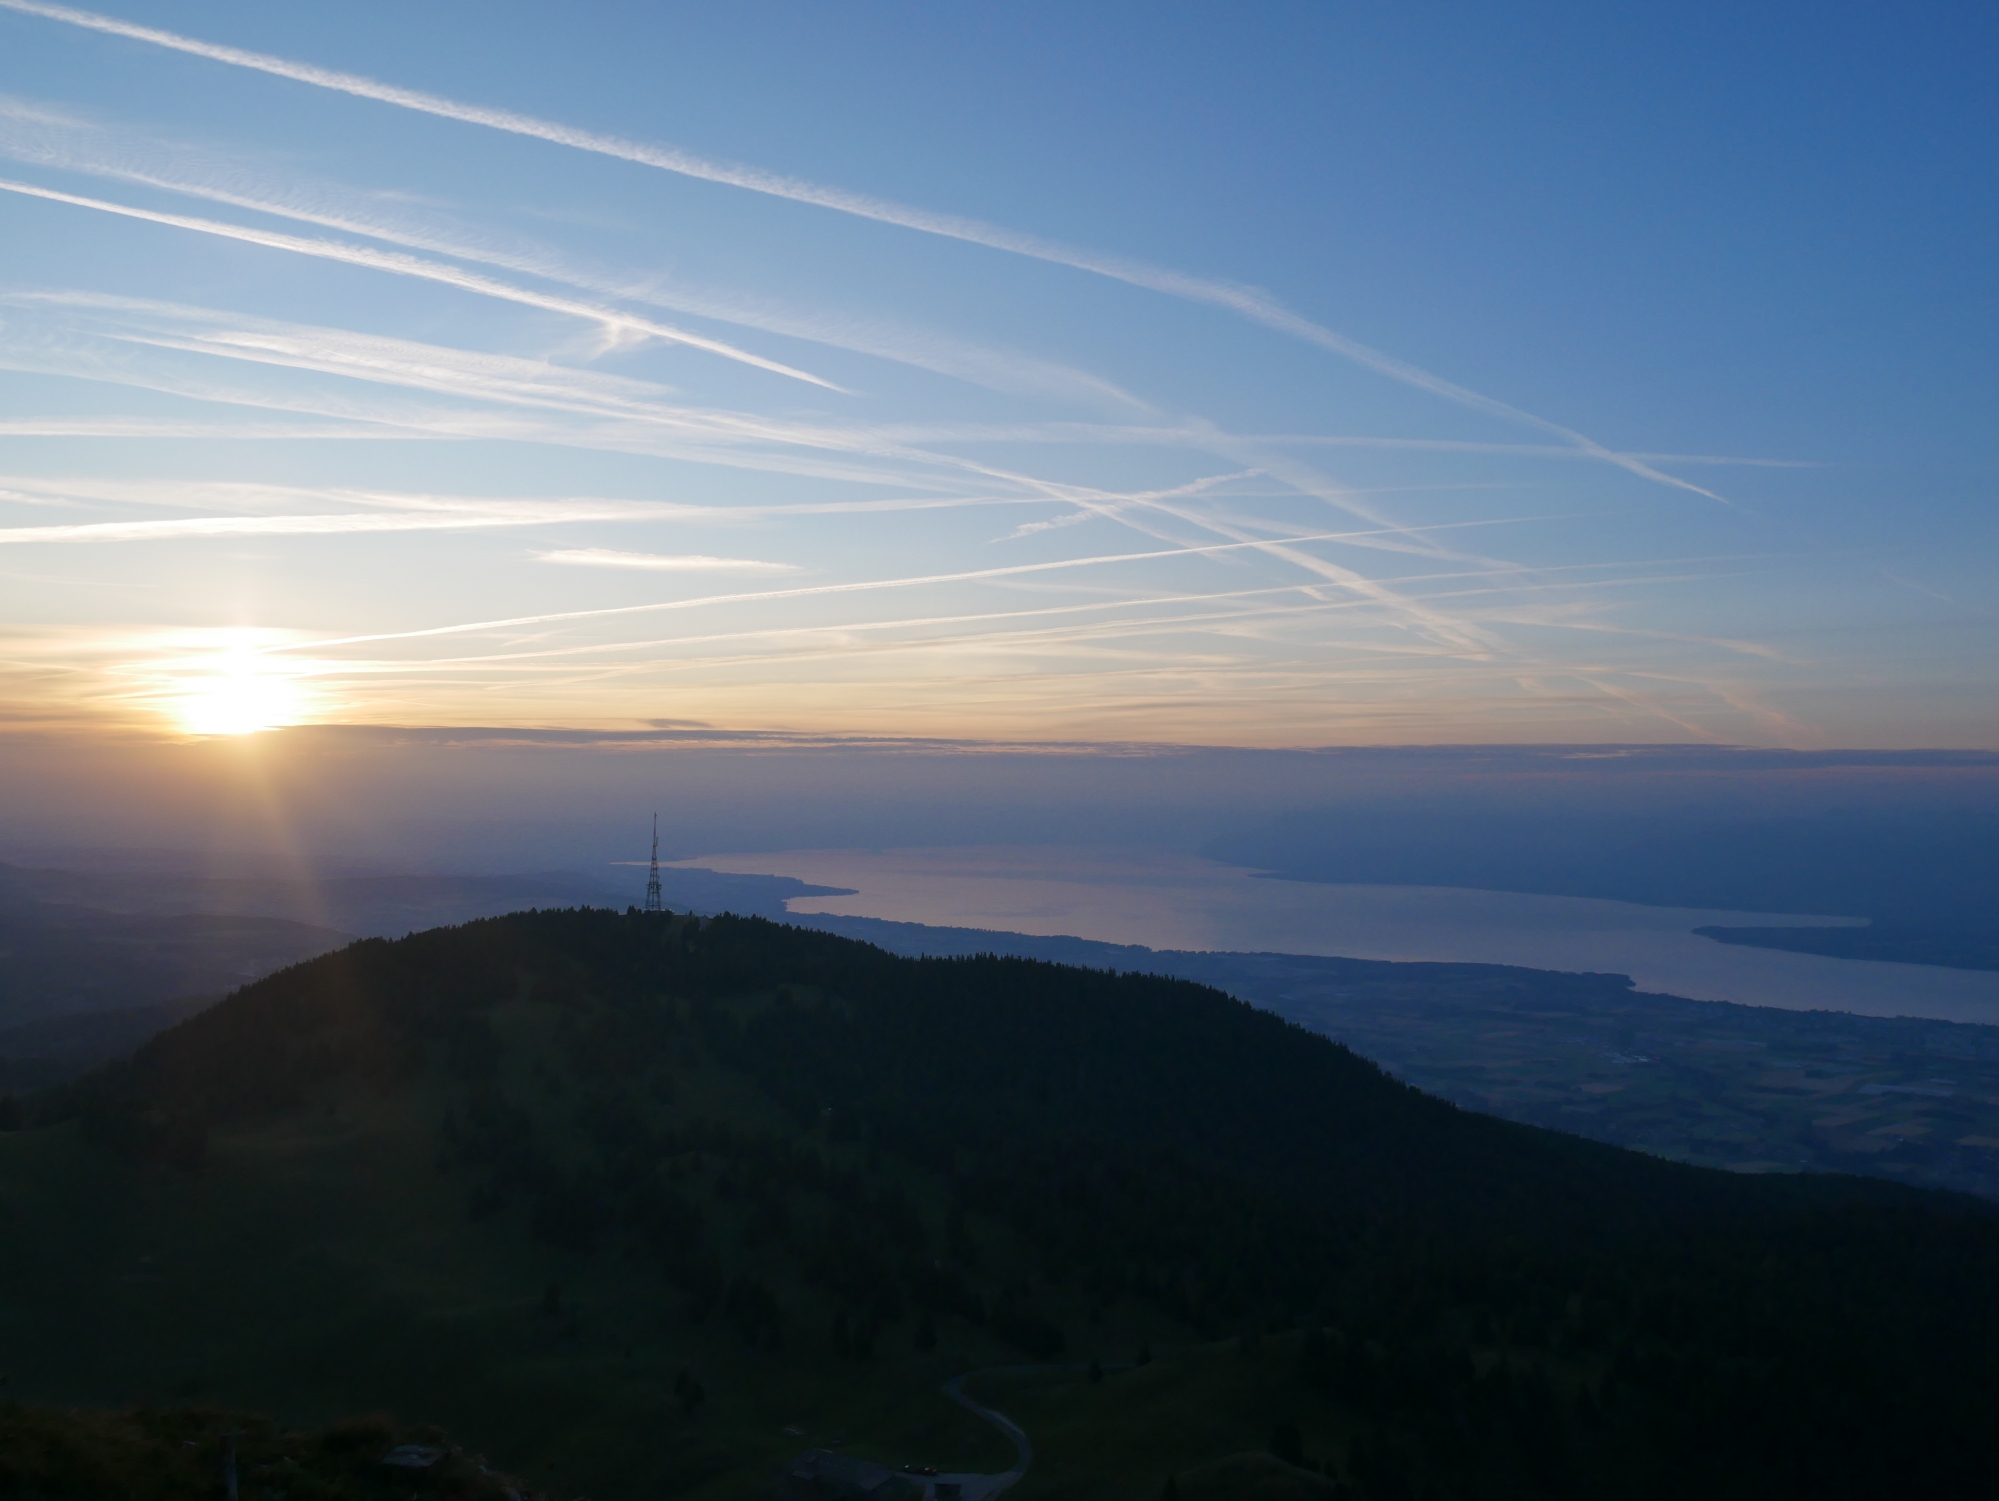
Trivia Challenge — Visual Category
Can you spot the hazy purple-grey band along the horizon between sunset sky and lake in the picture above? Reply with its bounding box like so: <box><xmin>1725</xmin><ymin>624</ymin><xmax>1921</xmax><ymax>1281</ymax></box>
<box><xmin>0</xmin><ymin>726</ymin><xmax>1999</xmax><ymax>855</ymax></box>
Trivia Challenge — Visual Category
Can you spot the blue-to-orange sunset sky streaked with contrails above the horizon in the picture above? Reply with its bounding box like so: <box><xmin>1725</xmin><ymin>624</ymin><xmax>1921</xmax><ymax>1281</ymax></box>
<box><xmin>0</xmin><ymin>0</ymin><xmax>1999</xmax><ymax>750</ymax></box>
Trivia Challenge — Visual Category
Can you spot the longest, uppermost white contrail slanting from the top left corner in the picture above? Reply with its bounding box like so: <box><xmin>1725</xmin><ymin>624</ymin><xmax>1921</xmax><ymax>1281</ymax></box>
<box><xmin>0</xmin><ymin>0</ymin><xmax>1731</xmax><ymax>506</ymax></box>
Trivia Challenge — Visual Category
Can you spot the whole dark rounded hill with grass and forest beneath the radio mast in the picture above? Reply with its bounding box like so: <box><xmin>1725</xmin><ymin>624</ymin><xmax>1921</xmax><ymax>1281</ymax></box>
<box><xmin>0</xmin><ymin>911</ymin><xmax>1999</xmax><ymax>1501</ymax></box>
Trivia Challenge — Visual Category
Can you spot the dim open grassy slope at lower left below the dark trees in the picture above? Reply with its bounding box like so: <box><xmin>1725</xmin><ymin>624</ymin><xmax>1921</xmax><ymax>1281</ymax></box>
<box><xmin>0</xmin><ymin>967</ymin><xmax>1159</xmax><ymax>1497</ymax></box>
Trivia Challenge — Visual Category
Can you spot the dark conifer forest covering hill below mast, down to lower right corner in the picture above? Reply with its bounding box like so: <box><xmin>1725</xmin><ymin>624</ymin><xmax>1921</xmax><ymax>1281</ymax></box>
<box><xmin>44</xmin><ymin>911</ymin><xmax>1999</xmax><ymax>1499</ymax></box>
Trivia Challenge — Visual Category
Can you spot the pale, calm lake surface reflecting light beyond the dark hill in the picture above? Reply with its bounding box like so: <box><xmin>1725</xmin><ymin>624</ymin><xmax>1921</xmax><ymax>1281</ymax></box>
<box><xmin>680</xmin><ymin>847</ymin><xmax>1999</xmax><ymax>1023</ymax></box>
